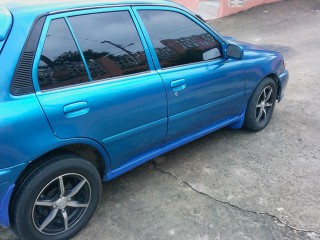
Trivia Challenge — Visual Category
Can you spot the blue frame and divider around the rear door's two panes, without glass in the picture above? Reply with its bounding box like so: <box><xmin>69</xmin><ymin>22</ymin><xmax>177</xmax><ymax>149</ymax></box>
<box><xmin>32</xmin><ymin>6</ymin><xmax>155</xmax><ymax>93</ymax></box>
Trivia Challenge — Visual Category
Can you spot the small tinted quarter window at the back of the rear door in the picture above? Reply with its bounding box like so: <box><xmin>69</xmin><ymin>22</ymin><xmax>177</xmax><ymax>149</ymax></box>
<box><xmin>38</xmin><ymin>19</ymin><xmax>88</xmax><ymax>90</ymax></box>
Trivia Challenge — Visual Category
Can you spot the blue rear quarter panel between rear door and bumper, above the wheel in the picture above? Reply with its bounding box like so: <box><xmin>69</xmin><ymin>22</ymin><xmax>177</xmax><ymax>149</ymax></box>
<box><xmin>0</xmin><ymin>94</ymin><xmax>57</xmax><ymax>169</ymax></box>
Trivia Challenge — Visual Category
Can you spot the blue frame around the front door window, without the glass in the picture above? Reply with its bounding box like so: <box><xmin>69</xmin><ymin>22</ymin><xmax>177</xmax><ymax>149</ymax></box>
<box><xmin>132</xmin><ymin>6</ymin><xmax>227</xmax><ymax>70</ymax></box>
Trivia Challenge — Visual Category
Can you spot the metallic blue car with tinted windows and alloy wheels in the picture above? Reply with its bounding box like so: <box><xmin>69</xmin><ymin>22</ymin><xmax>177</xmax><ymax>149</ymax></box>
<box><xmin>0</xmin><ymin>0</ymin><xmax>288</xmax><ymax>240</ymax></box>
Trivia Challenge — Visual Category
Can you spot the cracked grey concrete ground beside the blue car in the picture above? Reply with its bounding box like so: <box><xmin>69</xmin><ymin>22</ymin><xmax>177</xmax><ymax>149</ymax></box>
<box><xmin>0</xmin><ymin>0</ymin><xmax>320</xmax><ymax>240</ymax></box>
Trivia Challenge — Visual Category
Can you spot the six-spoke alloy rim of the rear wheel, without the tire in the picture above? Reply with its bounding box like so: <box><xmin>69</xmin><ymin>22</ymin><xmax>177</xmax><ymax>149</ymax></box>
<box><xmin>32</xmin><ymin>173</ymin><xmax>91</xmax><ymax>235</ymax></box>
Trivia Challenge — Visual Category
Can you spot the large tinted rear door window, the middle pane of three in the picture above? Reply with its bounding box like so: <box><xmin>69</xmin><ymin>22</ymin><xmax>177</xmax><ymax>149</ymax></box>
<box><xmin>69</xmin><ymin>11</ymin><xmax>149</xmax><ymax>80</ymax></box>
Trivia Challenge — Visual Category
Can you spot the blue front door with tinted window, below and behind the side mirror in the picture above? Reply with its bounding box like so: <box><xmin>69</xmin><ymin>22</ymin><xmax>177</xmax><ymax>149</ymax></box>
<box><xmin>134</xmin><ymin>7</ymin><xmax>245</xmax><ymax>143</ymax></box>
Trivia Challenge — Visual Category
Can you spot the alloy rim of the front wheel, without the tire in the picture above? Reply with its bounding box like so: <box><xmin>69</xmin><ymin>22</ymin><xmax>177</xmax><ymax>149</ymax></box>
<box><xmin>256</xmin><ymin>86</ymin><xmax>274</xmax><ymax>124</ymax></box>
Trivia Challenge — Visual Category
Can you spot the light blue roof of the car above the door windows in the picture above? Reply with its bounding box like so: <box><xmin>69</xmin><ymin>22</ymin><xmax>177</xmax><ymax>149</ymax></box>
<box><xmin>0</xmin><ymin>0</ymin><xmax>179</xmax><ymax>16</ymax></box>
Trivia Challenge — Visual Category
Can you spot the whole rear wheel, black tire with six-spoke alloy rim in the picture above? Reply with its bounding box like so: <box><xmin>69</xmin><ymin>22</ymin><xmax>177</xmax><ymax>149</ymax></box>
<box><xmin>11</xmin><ymin>155</ymin><xmax>101</xmax><ymax>240</ymax></box>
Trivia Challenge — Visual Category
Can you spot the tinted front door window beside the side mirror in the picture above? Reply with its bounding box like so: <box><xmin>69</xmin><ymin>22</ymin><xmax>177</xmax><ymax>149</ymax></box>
<box><xmin>139</xmin><ymin>10</ymin><xmax>221</xmax><ymax>67</ymax></box>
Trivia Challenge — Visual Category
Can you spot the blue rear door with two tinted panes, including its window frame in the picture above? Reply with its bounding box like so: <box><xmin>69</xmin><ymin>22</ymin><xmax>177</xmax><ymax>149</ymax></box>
<box><xmin>33</xmin><ymin>7</ymin><xmax>167</xmax><ymax>170</ymax></box>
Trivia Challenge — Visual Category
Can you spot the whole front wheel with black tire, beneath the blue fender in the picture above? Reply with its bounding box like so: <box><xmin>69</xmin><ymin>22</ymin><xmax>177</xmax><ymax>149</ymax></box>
<box><xmin>243</xmin><ymin>77</ymin><xmax>277</xmax><ymax>132</ymax></box>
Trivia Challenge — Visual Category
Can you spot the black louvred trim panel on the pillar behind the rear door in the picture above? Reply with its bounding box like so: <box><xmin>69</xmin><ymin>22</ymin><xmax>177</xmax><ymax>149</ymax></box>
<box><xmin>10</xmin><ymin>15</ymin><xmax>46</xmax><ymax>96</ymax></box>
